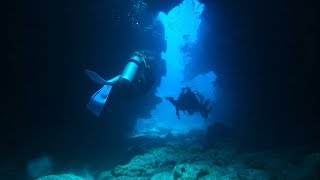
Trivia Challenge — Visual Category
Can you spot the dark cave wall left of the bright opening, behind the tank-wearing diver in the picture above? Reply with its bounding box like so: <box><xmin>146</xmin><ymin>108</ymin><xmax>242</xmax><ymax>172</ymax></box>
<box><xmin>0</xmin><ymin>1</ymin><xmax>168</xmax><ymax>179</ymax></box>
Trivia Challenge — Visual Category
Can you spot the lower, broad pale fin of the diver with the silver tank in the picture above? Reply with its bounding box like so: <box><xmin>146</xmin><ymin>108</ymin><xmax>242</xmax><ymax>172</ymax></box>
<box><xmin>87</xmin><ymin>85</ymin><xmax>112</xmax><ymax>116</ymax></box>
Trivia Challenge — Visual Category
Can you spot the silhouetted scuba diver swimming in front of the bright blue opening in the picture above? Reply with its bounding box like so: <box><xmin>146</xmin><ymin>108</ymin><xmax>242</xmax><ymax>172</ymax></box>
<box><xmin>166</xmin><ymin>87</ymin><xmax>212</xmax><ymax>119</ymax></box>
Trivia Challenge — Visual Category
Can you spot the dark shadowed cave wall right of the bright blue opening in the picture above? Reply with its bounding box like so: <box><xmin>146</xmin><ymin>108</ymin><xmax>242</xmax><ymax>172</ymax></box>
<box><xmin>201</xmin><ymin>1</ymin><xmax>320</xmax><ymax>148</ymax></box>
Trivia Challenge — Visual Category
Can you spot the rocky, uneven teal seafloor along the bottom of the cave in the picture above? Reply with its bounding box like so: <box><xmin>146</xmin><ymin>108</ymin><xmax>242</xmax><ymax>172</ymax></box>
<box><xmin>38</xmin><ymin>131</ymin><xmax>320</xmax><ymax>180</ymax></box>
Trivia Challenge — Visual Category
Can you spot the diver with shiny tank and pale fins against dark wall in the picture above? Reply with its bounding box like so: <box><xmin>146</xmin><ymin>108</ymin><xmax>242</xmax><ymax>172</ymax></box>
<box><xmin>85</xmin><ymin>51</ymin><xmax>152</xmax><ymax>116</ymax></box>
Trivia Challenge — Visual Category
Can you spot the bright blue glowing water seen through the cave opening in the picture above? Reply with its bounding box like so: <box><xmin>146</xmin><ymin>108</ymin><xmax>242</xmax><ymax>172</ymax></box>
<box><xmin>135</xmin><ymin>0</ymin><xmax>216</xmax><ymax>135</ymax></box>
